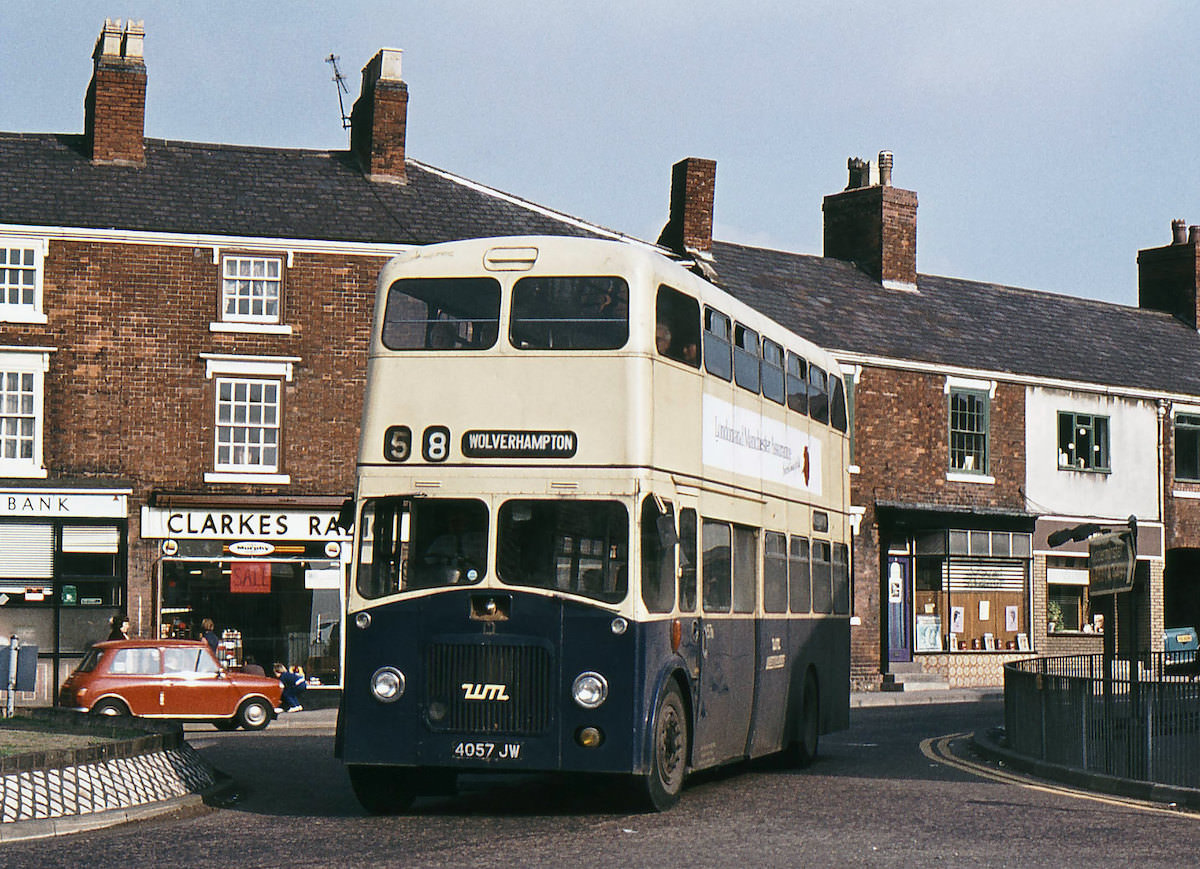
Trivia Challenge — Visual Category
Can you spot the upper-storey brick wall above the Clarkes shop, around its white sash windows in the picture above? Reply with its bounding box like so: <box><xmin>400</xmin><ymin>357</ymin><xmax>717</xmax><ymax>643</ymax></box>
<box><xmin>0</xmin><ymin>241</ymin><xmax>386</xmax><ymax>617</ymax></box>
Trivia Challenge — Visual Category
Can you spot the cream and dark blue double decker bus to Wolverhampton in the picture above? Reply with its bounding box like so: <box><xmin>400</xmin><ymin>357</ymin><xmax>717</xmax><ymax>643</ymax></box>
<box><xmin>336</xmin><ymin>236</ymin><xmax>851</xmax><ymax>814</ymax></box>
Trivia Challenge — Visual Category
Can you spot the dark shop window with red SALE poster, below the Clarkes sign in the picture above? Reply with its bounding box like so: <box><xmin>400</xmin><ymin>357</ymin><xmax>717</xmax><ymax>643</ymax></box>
<box><xmin>160</xmin><ymin>561</ymin><xmax>341</xmax><ymax>685</ymax></box>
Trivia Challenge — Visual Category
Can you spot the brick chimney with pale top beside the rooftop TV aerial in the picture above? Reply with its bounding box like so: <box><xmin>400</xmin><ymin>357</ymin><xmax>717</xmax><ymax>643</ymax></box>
<box><xmin>350</xmin><ymin>48</ymin><xmax>408</xmax><ymax>184</ymax></box>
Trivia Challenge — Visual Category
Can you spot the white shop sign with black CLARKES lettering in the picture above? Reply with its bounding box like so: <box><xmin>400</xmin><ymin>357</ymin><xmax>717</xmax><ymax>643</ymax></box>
<box><xmin>142</xmin><ymin>507</ymin><xmax>350</xmax><ymax>540</ymax></box>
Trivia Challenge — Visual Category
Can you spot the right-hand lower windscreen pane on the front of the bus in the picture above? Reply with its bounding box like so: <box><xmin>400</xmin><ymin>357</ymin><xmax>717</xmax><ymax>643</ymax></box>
<box><xmin>496</xmin><ymin>501</ymin><xmax>629</xmax><ymax>604</ymax></box>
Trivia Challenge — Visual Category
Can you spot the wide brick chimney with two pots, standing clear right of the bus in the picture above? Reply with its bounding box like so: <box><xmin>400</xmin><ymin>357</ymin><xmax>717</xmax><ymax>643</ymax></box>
<box><xmin>822</xmin><ymin>151</ymin><xmax>917</xmax><ymax>289</ymax></box>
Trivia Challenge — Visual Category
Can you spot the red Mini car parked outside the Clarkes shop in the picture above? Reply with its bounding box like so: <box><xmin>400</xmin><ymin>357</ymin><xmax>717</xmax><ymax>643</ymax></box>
<box><xmin>59</xmin><ymin>640</ymin><xmax>282</xmax><ymax>730</ymax></box>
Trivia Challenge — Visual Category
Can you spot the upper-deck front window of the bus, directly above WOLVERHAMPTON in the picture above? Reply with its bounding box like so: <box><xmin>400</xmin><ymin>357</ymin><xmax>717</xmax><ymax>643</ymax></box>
<box><xmin>509</xmin><ymin>277</ymin><xmax>629</xmax><ymax>350</ymax></box>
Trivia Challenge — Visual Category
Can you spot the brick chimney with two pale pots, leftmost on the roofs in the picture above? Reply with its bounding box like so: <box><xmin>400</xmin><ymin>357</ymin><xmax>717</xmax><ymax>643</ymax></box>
<box><xmin>83</xmin><ymin>18</ymin><xmax>146</xmax><ymax>166</ymax></box>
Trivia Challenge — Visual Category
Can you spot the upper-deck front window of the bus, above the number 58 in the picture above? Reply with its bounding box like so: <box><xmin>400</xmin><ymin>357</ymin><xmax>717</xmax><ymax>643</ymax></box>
<box><xmin>383</xmin><ymin>277</ymin><xmax>500</xmax><ymax>350</ymax></box>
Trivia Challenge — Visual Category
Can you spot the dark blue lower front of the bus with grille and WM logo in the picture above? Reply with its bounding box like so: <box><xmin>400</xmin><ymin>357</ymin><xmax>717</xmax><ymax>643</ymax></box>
<box><xmin>338</xmin><ymin>591</ymin><xmax>648</xmax><ymax>772</ymax></box>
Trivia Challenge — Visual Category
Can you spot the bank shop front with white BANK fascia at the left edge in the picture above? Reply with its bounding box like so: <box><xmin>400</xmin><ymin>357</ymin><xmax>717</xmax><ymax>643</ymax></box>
<box><xmin>0</xmin><ymin>485</ymin><xmax>131</xmax><ymax>703</ymax></box>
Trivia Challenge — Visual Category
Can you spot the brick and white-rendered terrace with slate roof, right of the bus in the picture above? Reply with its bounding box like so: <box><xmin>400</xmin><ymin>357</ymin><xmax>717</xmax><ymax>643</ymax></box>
<box><xmin>660</xmin><ymin>152</ymin><xmax>1200</xmax><ymax>688</ymax></box>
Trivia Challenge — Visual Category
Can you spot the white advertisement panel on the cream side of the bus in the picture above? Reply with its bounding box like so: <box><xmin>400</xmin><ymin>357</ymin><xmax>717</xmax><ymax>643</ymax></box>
<box><xmin>703</xmin><ymin>395</ymin><xmax>822</xmax><ymax>495</ymax></box>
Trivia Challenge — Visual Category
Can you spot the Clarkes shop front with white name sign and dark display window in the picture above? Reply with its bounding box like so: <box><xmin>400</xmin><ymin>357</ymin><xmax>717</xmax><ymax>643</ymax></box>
<box><xmin>142</xmin><ymin>495</ymin><xmax>350</xmax><ymax>689</ymax></box>
